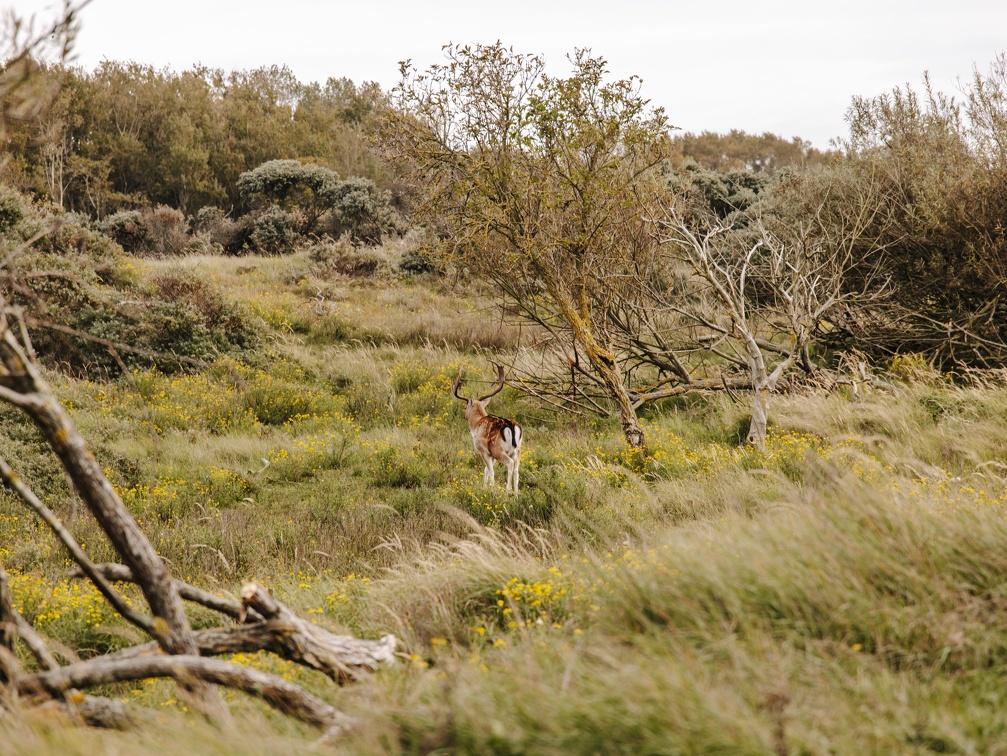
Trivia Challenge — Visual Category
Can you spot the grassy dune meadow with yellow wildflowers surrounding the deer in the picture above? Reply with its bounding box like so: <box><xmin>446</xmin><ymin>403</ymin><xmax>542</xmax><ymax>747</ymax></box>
<box><xmin>0</xmin><ymin>252</ymin><xmax>1007</xmax><ymax>754</ymax></box>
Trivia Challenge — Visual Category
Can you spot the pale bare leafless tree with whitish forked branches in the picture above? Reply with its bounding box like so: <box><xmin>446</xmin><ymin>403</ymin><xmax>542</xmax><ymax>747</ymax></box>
<box><xmin>640</xmin><ymin>192</ymin><xmax>885</xmax><ymax>448</ymax></box>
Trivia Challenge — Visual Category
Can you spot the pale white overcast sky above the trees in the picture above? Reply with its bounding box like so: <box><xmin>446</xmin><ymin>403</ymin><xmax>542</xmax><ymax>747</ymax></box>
<box><xmin>7</xmin><ymin>0</ymin><xmax>1007</xmax><ymax>148</ymax></box>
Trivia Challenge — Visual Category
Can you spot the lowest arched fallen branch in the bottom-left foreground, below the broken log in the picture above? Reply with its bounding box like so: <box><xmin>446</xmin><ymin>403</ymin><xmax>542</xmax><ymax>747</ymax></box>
<box><xmin>17</xmin><ymin>654</ymin><xmax>351</xmax><ymax>735</ymax></box>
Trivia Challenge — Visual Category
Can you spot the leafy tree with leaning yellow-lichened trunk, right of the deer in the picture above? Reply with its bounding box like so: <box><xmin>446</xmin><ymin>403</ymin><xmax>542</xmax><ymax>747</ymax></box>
<box><xmin>383</xmin><ymin>42</ymin><xmax>669</xmax><ymax>447</ymax></box>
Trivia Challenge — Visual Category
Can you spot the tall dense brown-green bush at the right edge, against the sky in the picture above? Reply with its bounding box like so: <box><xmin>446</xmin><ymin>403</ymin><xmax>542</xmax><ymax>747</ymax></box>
<box><xmin>817</xmin><ymin>55</ymin><xmax>1007</xmax><ymax>367</ymax></box>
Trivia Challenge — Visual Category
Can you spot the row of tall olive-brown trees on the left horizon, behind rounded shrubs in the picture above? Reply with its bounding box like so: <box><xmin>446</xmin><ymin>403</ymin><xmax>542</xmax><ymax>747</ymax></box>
<box><xmin>0</xmin><ymin>61</ymin><xmax>390</xmax><ymax>218</ymax></box>
